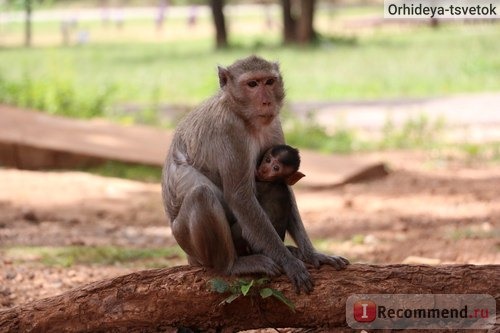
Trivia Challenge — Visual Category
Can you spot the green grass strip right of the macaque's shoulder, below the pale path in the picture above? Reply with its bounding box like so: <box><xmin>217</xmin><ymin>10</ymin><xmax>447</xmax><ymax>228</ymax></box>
<box><xmin>283</xmin><ymin>112</ymin><xmax>500</xmax><ymax>164</ymax></box>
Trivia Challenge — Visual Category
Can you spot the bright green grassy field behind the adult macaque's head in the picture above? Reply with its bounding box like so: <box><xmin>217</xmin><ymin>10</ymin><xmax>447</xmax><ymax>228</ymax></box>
<box><xmin>0</xmin><ymin>6</ymin><xmax>500</xmax><ymax>111</ymax></box>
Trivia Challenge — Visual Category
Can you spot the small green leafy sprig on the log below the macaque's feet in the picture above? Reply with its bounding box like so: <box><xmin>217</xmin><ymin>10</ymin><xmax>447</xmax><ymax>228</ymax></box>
<box><xmin>209</xmin><ymin>278</ymin><xmax>295</xmax><ymax>312</ymax></box>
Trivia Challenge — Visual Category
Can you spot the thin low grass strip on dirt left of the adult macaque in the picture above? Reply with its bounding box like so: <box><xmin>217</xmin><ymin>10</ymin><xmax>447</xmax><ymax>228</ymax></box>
<box><xmin>0</xmin><ymin>246</ymin><xmax>185</xmax><ymax>267</ymax></box>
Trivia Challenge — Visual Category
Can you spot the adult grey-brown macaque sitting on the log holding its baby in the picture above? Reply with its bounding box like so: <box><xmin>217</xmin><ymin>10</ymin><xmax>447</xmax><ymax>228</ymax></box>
<box><xmin>162</xmin><ymin>56</ymin><xmax>348</xmax><ymax>292</ymax></box>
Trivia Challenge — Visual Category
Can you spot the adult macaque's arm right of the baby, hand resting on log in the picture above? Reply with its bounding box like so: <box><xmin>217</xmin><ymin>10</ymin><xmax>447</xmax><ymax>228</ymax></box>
<box><xmin>288</xmin><ymin>187</ymin><xmax>349</xmax><ymax>269</ymax></box>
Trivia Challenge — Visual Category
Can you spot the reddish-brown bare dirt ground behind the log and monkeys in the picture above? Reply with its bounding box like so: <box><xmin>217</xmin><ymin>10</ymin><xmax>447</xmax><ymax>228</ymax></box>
<box><xmin>0</xmin><ymin>152</ymin><xmax>500</xmax><ymax>309</ymax></box>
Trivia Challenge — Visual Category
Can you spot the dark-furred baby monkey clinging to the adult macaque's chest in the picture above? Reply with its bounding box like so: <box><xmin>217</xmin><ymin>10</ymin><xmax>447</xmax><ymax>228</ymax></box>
<box><xmin>231</xmin><ymin>145</ymin><xmax>305</xmax><ymax>256</ymax></box>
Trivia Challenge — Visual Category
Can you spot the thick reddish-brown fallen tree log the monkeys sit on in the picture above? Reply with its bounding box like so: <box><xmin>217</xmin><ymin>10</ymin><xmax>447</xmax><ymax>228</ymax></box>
<box><xmin>0</xmin><ymin>264</ymin><xmax>500</xmax><ymax>332</ymax></box>
